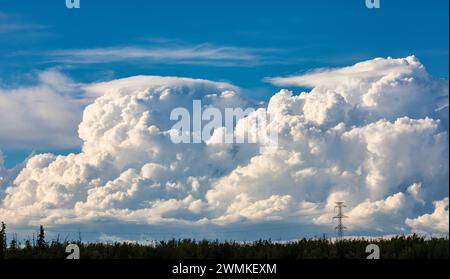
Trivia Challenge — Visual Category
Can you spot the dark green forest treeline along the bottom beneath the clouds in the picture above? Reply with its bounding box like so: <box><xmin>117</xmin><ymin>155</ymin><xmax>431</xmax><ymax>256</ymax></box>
<box><xmin>0</xmin><ymin>223</ymin><xmax>449</xmax><ymax>259</ymax></box>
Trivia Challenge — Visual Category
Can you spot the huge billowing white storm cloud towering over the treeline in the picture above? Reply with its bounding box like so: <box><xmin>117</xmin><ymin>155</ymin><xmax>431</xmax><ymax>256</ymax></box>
<box><xmin>0</xmin><ymin>56</ymin><xmax>449</xmax><ymax>240</ymax></box>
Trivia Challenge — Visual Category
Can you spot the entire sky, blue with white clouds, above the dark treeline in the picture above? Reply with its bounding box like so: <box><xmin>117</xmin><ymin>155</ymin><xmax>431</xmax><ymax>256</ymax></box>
<box><xmin>0</xmin><ymin>0</ymin><xmax>449</xmax><ymax>242</ymax></box>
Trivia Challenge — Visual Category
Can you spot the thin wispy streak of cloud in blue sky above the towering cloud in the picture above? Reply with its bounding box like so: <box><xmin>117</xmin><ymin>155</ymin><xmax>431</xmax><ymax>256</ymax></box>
<box><xmin>46</xmin><ymin>42</ymin><xmax>277</xmax><ymax>67</ymax></box>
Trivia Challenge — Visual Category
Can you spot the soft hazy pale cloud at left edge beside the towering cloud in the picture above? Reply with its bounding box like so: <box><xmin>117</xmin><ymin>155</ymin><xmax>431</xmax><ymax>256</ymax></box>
<box><xmin>0</xmin><ymin>70</ymin><xmax>91</xmax><ymax>149</ymax></box>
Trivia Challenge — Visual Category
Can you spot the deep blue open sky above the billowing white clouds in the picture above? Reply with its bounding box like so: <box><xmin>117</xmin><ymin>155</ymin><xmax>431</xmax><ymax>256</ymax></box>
<box><xmin>0</xmin><ymin>0</ymin><xmax>449</xmax><ymax>166</ymax></box>
